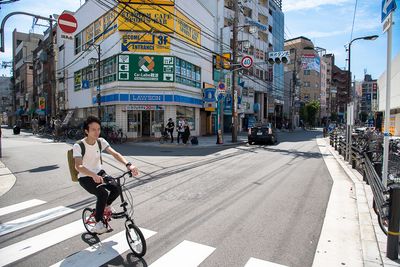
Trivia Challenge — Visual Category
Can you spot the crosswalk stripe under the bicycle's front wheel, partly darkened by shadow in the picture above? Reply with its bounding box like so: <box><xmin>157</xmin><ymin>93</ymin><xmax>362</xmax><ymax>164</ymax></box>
<box><xmin>51</xmin><ymin>228</ymin><xmax>157</xmax><ymax>267</ymax></box>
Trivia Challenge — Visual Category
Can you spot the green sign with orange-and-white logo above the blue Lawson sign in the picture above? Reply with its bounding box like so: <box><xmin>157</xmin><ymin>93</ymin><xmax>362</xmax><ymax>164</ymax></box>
<box><xmin>118</xmin><ymin>54</ymin><xmax>175</xmax><ymax>82</ymax></box>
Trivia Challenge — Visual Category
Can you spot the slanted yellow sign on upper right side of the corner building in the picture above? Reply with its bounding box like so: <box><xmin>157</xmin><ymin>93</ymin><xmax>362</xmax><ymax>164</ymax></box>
<box><xmin>175</xmin><ymin>10</ymin><xmax>201</xmax><ymax>47</ymax></box>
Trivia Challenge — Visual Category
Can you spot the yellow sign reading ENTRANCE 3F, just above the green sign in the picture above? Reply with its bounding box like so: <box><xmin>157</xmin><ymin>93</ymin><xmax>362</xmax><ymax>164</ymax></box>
<box><xmin>121</xmin><ymin>32</ymin><xmax>171</xmax><ymax>53</ymax></box>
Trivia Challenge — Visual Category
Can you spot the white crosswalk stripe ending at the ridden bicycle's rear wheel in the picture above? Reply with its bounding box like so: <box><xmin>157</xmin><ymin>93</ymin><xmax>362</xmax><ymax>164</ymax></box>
<box><xmin>0</xmin><ymin>220</ymin><xmax>86</xmax><ymax>266</ymax></box>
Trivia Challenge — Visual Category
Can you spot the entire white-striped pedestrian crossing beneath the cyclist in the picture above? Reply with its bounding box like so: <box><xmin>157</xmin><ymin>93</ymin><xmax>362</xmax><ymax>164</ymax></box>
<box><xmin>0</xmin><ymin>199</ymin><xmax>284</xmax><ymax>267</ymax></box>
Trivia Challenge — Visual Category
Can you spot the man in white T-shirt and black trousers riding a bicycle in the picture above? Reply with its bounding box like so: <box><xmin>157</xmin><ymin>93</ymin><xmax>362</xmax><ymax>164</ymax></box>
<box><xmin>73</xmin><ymin>116</ymin><xmax>139</xmax><ymax>234</ymax></box>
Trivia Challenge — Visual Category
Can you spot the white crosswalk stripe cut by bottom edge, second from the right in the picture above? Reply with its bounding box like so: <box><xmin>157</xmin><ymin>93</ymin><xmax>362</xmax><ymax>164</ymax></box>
<box><xmin>149</xmin><ymin>240</ymin><xmax>215</xmax><ymax>267</ymax></box>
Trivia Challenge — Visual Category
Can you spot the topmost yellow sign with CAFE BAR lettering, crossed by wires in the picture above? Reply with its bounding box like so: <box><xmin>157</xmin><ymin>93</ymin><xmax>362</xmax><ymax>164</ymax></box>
<box><xmin>118</xmin><ymin>4</ymin><xmax>174</xmax><ymax>32</ymax></box>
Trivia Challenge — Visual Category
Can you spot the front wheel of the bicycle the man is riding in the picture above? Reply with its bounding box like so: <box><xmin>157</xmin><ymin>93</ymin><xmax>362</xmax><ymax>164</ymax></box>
<box><xmin>125</xmin><ymin>220</ymin><xmax>147</xmax><ymax>258</ymax></box>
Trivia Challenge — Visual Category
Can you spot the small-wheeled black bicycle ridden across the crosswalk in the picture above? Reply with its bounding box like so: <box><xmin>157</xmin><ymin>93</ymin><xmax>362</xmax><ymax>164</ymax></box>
<box><xmin>82</xmin><ymin>171</ymin><xmax>147</xmax><ymax>258</ymax></box>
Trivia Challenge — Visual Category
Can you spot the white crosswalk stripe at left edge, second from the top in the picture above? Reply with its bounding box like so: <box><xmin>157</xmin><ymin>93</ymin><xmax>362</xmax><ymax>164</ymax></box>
<box><xmin>0</xmin><ymin>206</ymin><xmax>75</xmax><ymax>236</ymax></box>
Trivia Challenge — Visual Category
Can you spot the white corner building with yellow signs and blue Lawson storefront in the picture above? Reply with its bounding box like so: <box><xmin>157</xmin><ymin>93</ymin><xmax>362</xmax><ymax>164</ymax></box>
<box><xmin>57</xmin><ymin>1</ymin><xmax>217</xmax><ymax>138</ymax></box>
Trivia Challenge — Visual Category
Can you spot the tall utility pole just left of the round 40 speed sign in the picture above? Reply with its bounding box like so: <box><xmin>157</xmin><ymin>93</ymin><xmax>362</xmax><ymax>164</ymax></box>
<box><xmin>231</xmin><ymin>0</ymin><xmax>239</xmax><ymax>143</ymax></box>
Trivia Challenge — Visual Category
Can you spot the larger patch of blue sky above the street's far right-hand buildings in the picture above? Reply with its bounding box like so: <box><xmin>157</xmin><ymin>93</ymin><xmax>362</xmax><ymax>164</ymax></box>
<box><xmin>283</xmin><ymin>0</ymin><xmax>400</xmax><ymax>80</ymax></box>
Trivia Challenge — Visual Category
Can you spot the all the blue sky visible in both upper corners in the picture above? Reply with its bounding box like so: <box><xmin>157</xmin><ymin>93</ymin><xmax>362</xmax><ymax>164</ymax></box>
<box><xmin>0</xmin><ymin>0</ymin><xmax>400</xmax><ymax>80</ymax></box>
